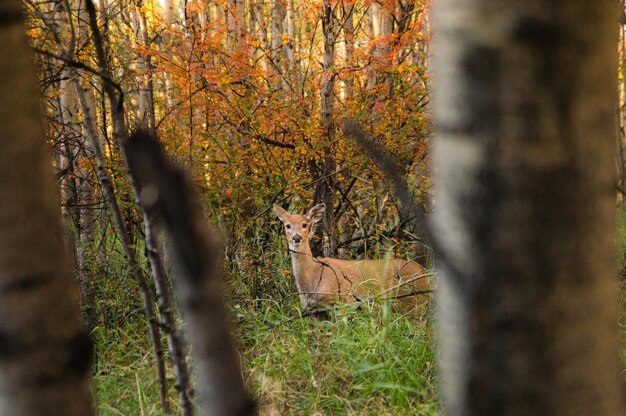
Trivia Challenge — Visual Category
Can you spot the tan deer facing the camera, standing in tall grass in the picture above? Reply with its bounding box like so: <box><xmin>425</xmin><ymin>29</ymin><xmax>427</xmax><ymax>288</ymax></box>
<box><xmin>273</xmin><ymin>204</ymin><xmax>430</xmax><ymax>316</ymax></box>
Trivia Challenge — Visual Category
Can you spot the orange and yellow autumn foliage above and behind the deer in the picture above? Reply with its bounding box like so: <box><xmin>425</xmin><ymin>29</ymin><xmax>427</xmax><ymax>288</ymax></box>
<box><xmin>30</xmin><ymin>0</ymin><xmax>429</xmax><ymax>247</ymax></box>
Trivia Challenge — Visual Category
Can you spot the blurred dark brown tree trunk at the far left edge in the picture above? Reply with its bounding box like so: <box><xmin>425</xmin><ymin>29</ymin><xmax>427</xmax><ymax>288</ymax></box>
<box><xmin>0</xmin><ymin>1</ymin><xmax>93</xmax><ymax>416</ymax></box>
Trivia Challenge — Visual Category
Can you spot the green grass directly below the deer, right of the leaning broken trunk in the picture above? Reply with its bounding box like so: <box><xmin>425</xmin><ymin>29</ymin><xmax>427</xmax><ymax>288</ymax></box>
<box><xmin>238</xmin><ymin>304</ymin><xmax>438</xmax><ymax>415</ymax></box>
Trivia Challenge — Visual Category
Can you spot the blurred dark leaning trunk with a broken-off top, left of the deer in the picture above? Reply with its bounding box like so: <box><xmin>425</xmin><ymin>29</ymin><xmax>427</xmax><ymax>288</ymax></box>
<box><xmin>127</xmin><ymin>132</ymin><xmax>255</xmax><ymax>416</ymax></box>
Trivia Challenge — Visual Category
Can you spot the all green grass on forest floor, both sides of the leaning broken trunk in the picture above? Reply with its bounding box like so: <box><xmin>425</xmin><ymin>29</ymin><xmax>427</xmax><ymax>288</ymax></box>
<box><xmin>94</xmin><ymin>301</ymin><xmax>438</xmax><ymax>415</ymax></box>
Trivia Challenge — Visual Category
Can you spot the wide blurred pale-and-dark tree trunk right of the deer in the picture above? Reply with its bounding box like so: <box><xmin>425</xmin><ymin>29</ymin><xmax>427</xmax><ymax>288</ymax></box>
<box><xmin>434</xmin><ymin>0</ymin><xmax>624</xmax><ymax>416</ymax></box>
